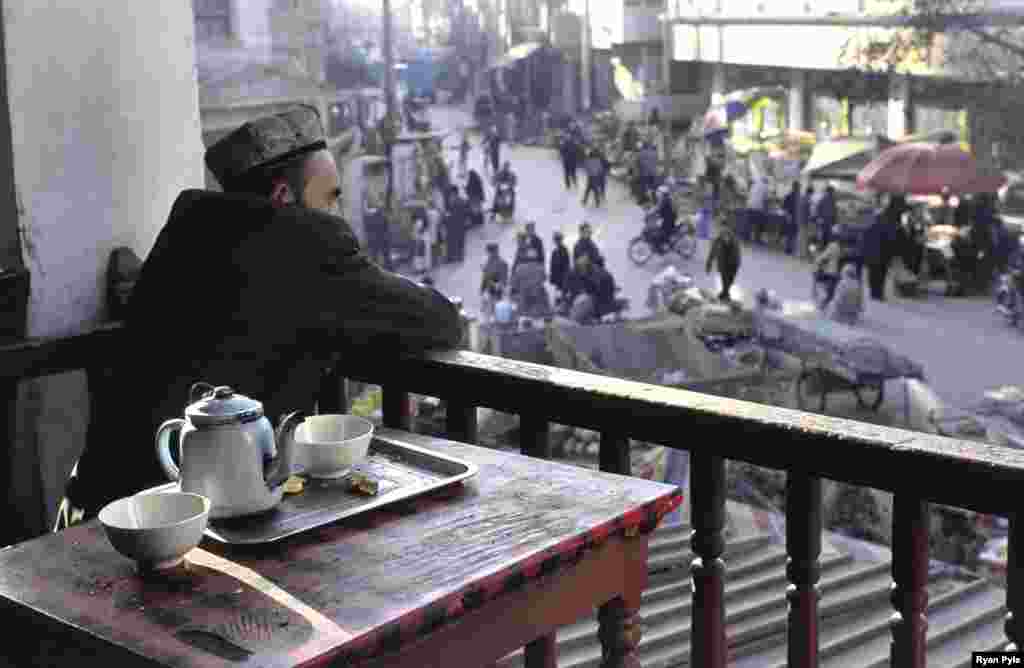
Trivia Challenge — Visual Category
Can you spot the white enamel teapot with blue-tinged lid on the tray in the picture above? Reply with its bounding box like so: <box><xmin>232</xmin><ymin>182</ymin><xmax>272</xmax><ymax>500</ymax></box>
<box><xmin>157</xmin><ymin>383</ymin><xmax>306</xmax><ymax>518</ymax></box>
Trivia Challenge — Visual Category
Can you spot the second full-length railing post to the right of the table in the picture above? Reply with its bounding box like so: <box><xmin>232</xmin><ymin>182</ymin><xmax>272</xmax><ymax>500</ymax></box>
<box><xmin>785</xmin><ymin>471</ymin><xmax>821</xmax><ymax>668</ymax></box>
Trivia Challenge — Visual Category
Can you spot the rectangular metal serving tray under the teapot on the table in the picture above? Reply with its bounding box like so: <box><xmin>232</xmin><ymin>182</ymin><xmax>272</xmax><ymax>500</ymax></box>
<box><xmin>141</xmin><ymin>436</ymin><xmax>477</xmax><ymax>545</ymax></box>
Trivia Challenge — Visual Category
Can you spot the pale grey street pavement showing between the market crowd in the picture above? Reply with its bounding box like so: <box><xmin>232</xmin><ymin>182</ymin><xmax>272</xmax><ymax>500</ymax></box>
<box><xmin>421</xmin><ymin>107</ymin><xmax>1024</xmax><ymax>408</ymax></box>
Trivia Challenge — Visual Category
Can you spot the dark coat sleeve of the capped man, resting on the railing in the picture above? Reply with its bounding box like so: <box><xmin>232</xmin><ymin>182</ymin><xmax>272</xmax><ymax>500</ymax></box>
<box><xmin>233</xmin><ymin>210</ymin><xmax>462</xmax><ymax>352</ymax></box>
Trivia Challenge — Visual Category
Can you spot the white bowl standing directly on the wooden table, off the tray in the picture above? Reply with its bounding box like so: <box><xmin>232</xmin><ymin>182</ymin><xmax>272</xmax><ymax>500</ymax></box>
<box><xmin>99</xmin><ymin>492</ymin><xmax>210</xmax><ymax>570</ymax></box>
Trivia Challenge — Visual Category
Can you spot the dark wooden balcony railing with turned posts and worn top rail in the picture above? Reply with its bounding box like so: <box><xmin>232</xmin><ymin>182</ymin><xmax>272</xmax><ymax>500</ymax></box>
<box><xmin>0</xmin><ymin>327</ymin><xmax>1024</xmax><ymax>668</ymax></box>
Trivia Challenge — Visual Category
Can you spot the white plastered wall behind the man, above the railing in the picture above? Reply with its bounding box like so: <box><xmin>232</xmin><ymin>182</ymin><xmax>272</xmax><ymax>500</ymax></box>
<box><xmin>3</xmin><ymin>0</ymin><xmax>203</xmax><ymax>336</ymax></box>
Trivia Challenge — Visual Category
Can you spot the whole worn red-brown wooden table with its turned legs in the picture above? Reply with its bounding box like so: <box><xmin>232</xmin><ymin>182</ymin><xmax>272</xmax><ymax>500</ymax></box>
<box><xmin>0</xmin><ymin>430</ymin><xmax>681</xmax><ymax>668</ymax></box>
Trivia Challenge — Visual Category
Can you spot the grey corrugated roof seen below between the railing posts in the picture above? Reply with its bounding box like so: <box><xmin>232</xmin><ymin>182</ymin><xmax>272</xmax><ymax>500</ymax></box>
<box><xmin>499</xmin><ymin>518</ymin><xmax>1006</xmax><ymax>668</ymax></box>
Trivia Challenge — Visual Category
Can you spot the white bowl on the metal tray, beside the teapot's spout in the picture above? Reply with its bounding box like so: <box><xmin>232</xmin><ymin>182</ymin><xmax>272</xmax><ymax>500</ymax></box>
<box><xmin>295</xmin><ymin>415</ymin><xmax>374</xmax><ymax>478</ymax></box>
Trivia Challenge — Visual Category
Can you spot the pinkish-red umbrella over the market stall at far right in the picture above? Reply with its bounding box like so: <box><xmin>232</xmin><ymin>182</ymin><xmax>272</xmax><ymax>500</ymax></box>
<box><xmin>857</xmin><ymin>142</ymin><xmax>1006</xmax><ymax>195</ymax></box>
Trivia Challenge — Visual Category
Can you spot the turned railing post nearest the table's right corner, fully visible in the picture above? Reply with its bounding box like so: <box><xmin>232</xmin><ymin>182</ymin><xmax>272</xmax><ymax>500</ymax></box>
<box><xmin>690</xmin><ymin>452</ymin><xmax>728</xmax><ymax>668</ymax></box>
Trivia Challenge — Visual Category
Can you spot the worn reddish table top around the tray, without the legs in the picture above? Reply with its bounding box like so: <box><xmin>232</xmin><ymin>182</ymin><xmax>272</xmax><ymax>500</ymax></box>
<box><xmin>0</xmin><ymin>429</ymin><xmax>681</xmax><ymax>668</ymax></box>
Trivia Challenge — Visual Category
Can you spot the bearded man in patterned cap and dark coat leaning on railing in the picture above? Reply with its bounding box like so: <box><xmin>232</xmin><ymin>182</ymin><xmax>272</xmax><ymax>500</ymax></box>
<box><xmin>68</xmin><ymin>106</ymin><xmax>462</xmax><ymax>517</ymax></box>
